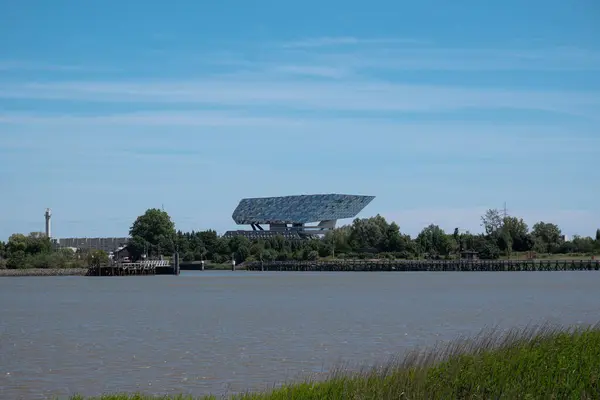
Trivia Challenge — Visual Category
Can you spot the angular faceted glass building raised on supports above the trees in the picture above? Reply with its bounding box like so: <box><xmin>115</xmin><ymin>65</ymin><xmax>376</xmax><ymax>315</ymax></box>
<box><xmin>225</xmin><ymin>194</ymin><xmax>375</xmax><ymax>239</ymax></box>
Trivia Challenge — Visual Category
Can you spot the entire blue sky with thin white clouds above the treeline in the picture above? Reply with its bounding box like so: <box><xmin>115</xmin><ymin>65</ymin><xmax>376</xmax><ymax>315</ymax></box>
<box><xmin>0</xmin><ymin>0</ymin><xmax>600</xmax><ymax>239</ymax></box>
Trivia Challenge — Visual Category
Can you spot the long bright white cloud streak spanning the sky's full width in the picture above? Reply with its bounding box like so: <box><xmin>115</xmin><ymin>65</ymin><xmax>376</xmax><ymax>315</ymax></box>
<box><xmin>0</xmin><ymin>79</ymin><xmax>600</xmax><ymax>118</ymax></box>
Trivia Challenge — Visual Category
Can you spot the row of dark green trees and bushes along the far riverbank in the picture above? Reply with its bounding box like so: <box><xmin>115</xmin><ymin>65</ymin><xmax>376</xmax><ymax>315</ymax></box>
<box><xmin>0</xmin><ymin>209</ymin><xmax>600</xmax><ymax>268</ymax></box>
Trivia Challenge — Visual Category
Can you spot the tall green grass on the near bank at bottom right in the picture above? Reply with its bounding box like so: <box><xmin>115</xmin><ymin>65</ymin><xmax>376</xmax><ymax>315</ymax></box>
<box><xmin>72</xmin><ymin>324</ymin><xmax>600</xmax><ymax>400</ymax></box>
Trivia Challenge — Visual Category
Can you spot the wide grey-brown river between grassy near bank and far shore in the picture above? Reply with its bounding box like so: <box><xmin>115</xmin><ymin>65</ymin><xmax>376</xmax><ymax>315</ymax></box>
<box><xmin>0</xmin><ymin>271</ymin><xmax>600</xmax><ymax>399</ymax></box>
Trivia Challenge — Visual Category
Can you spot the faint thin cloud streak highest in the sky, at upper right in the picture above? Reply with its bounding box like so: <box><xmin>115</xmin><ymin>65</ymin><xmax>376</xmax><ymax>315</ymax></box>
<box><xmin>274</xmin><ymin>37</ymin><xmax>600</xmax><ymax>71</ymax></box>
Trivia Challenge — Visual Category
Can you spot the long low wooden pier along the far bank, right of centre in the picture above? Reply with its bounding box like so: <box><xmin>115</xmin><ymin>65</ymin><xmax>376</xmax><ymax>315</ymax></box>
<box><xmin>244</xmin><ymin>259</ymin><xmax>600</xmax><ymax>272</ymax></box>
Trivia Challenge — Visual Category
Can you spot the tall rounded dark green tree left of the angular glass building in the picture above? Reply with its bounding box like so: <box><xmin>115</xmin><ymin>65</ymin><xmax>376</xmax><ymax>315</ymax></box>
<box><xmin>128</xmin><ymin>208</ymin><xmax>176</xmax><ymax>258</ymax></box>
